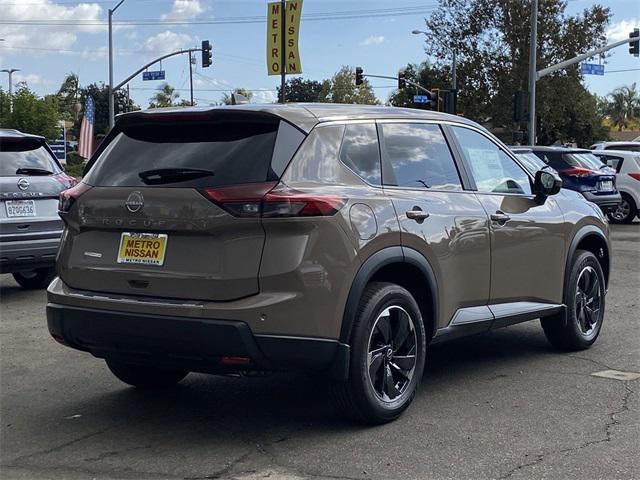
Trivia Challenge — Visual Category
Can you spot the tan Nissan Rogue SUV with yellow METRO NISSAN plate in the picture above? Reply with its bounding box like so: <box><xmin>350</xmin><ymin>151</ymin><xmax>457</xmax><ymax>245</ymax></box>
<box><xmin>47</xmin><ymin>104</ymin><xmax>610</xmax><ymax>423</ymax></box>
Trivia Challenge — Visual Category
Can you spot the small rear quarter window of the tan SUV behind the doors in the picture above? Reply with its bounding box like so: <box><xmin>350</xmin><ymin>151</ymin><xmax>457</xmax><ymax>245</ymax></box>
<box><xmin>340</xmin><ymin>123</ymin><xmax>382</xmax><ymax>185</ymax></box>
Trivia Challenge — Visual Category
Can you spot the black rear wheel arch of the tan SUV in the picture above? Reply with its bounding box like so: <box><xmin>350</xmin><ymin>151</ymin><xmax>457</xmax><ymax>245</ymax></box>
<box><xmin>340</xmin><ymin>246</ymin><xmax>438</xmax><ymax>343</ymax></box>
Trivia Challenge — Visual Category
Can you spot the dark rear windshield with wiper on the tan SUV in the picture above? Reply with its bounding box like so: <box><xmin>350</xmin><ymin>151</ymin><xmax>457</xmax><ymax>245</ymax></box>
<box><xmin>84</xmin><ymin>118</ymin><xmax>280</xmax><ymax>188</ymax></box>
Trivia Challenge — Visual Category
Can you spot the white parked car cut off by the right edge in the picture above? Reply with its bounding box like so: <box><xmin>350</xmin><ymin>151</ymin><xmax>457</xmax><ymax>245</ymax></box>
<box><xmin>593</xmin><ymin>150</ymin><xmax>640</xmax><ymax>223</ymax></box>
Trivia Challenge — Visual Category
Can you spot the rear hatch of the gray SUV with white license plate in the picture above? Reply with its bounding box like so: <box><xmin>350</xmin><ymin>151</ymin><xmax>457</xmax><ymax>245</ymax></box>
<box><xmin>0</xmin><ymin>135</ymin><xmax>70</xmax><ymax>237</ymax></box>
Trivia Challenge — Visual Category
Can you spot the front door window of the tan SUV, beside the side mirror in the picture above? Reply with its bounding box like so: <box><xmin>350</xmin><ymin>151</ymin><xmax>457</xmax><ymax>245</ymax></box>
<box><xmin>452</xmin><ymin>127</ymin><xmax>531</xmax><ymax>195</ymax></box>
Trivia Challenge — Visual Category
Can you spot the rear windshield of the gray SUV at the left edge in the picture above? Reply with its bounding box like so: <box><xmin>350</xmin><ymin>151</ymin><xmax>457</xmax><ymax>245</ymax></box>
<box><xmin>0</xmin><ymin>139</ymin><xmax>61</xmax><ymax>177</ymax></box>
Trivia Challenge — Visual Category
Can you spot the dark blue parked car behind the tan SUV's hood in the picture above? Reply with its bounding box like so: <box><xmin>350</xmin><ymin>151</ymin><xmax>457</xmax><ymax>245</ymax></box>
<box><xmin>530</xmin><ymin>146</ymin><xmax>622</xmax><ymax>213</ymax></box>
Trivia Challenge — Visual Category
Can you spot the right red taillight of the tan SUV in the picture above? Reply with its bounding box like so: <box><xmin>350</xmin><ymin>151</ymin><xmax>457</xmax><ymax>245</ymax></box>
<box><xmin>202</xmin><ymin>182</ymin><xmax>346</xmax><ymax>218</ymax></box>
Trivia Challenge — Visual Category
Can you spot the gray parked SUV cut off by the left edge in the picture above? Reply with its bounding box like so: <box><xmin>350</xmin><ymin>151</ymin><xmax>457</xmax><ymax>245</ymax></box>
<box><xmin>0</xmin><ymin>129</ymin><xmax>75</xmax><ymax>288</ymax></box>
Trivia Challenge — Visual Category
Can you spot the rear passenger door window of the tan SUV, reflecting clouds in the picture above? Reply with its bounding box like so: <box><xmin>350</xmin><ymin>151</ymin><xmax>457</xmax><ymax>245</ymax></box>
<box><xmin>382</xmin><ymin>123</ymin><xmax>462</xmax><ymax>190</ymax></box>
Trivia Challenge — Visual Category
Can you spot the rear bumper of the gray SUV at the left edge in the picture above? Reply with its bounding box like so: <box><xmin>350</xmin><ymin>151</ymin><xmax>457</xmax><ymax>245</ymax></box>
<box><xmin>0</xmin><ymin>232</ymin><xmax>61</xmax><ymax>273</ymax></box>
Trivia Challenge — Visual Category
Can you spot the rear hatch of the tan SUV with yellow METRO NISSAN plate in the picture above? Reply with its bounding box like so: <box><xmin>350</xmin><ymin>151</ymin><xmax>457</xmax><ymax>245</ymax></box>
<box><xmin>58</xmin><ymin>110</ymin><xmax>304</xmax><ymax>301</ymax></box>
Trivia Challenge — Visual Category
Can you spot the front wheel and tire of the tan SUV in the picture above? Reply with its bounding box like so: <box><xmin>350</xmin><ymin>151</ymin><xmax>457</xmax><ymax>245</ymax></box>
<box><xmin>541</xmin><ymin>250</ymin><xmax>605</xmax><ymax>351</ymax></box>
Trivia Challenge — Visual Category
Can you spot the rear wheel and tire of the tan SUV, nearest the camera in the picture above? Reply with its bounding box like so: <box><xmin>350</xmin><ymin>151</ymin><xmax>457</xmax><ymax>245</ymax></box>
<box><xmin>332</xmin><ymin>282</ymin><xmax>426</xmax><ymax>424</ymax></box>
